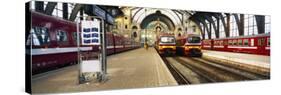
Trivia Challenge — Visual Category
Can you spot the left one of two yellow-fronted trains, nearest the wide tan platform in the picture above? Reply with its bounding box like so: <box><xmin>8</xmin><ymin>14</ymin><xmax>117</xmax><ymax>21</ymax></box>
<box><xmin>156</xmin><ymin>34</ymin><xmax>176</xmax><ymax>55</ymax></box>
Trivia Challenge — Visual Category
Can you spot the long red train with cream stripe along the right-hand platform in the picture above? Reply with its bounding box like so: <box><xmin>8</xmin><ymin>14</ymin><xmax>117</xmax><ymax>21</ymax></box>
<box><xmin>202</xmin><ymin>34</ymin><xmax>270</xmax><ymax>56</ymax></box>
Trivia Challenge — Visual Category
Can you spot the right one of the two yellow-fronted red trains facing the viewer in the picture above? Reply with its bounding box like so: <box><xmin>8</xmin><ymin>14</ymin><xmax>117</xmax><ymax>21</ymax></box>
<box><xmin>177</xmin><ymin>34</ymin><xmax>203</xmax><ymax>57</ymax></box>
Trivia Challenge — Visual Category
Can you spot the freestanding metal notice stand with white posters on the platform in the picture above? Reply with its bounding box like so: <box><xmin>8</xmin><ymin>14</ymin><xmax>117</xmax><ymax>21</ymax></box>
<box><xmin>76</xmin><ymin>16</ymin><xmax>107</xmax><ymax>84</ymax></box>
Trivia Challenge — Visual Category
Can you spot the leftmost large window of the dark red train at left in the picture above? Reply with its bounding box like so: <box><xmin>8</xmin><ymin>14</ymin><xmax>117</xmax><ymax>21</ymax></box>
<box><xmin>27</xmin><ymin>27</ymin><xmax>50</xmax><ymax>46</ymax></box>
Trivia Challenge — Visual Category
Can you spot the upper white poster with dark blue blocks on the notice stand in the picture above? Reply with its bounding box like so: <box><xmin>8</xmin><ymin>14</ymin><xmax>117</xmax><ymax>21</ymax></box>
<box><xmin>81</xmin><ymin>19</ymin><xmax>101</xmax><ymax>45</ymax></box>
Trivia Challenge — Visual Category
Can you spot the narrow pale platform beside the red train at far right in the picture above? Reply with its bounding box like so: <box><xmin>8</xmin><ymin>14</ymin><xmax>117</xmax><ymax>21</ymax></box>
<box><xmin>202</xmin><ymin>50</ymin><xmax>270</xmax><ymax>74</ymax></box>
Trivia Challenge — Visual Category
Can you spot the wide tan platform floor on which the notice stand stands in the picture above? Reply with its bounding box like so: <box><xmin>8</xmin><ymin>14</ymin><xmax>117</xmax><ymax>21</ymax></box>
<box><xmin>32</xmin><ymin>48</ymin><xmax>178</xmax><ymax>93</ymax></box>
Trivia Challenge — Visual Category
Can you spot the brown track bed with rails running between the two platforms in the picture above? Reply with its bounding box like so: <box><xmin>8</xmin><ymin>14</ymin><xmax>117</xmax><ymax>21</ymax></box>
<box><xmin>162</xmin><ymin>57</ymin><xmax>269</xmax><ymax>84</ymax></box>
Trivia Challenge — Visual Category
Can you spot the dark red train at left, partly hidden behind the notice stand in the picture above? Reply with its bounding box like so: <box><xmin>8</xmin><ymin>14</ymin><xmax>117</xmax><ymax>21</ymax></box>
<box><xmin>26</xmin><ymin>11</ymin><xmax>140</xmax><ymax>74</ymax></box>
